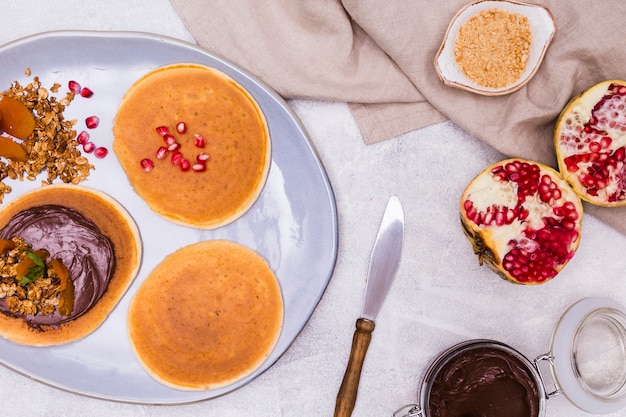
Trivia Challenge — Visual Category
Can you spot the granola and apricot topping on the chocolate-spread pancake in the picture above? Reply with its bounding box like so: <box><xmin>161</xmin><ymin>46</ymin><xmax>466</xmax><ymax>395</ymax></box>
<box><xmin>0</xmin><ymin>237</ymin><xmax>66</xmax><ymax>315</ymax></box>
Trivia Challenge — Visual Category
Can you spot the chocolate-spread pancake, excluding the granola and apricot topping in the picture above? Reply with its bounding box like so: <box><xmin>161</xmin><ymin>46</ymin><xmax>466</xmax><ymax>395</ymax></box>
<box><xmin>0</xmin><ymin>184</ymin><xmax>142</xmax><ymax>346</ymax></box>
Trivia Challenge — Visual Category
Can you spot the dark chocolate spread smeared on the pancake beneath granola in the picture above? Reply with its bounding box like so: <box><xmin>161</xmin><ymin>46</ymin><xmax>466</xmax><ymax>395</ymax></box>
<box><xmin>0</xmin><ymin>205</ymin><xmax>115</xmax><ymax>328</ymax></box>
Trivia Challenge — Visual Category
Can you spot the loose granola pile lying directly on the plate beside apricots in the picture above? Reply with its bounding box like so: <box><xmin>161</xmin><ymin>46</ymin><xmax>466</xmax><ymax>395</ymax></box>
<box><xmin>0</xmin><ymin>70</ymin><xmax>94</xmax><ymax>203</ymax></box>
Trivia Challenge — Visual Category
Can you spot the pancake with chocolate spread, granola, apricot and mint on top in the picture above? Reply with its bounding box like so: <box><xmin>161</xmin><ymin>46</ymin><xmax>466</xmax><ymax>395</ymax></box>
<box><xmin>0</xmin><ymin>184</ymin><xmax>142</xmax><ymax>346</ymax></box>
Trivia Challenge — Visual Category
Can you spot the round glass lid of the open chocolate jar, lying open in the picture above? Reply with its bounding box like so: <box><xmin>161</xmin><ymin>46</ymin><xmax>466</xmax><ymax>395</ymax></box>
<box><xmin>551</xmin><ymin>297</ymin><xmax>626</xmax><ymax>414</ymax></box>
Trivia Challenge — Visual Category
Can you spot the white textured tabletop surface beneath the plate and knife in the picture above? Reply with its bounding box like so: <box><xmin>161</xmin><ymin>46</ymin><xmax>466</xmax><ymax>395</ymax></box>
<box><xmin>0</xmin><ymin>0</ymin><xmax>626</xmax><ymax>417</ymax></box>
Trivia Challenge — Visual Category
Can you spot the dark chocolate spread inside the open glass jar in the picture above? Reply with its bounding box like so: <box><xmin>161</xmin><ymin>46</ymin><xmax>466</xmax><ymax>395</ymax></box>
<box><xmin>427</xmin><ymin>346</ymin><xmax>539</xmax><ymax>417</ymax></box>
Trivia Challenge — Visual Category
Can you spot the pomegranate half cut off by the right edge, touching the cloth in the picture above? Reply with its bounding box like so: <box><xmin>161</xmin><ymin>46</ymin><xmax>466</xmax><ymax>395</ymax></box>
<box><xmin>554</xmin><ymin>80</ymin><xmax>626</xmax><ymax>206</ymax></box>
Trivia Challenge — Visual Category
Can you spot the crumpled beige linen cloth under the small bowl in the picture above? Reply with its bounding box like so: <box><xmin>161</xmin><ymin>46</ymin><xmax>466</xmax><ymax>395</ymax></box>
<box><xmin>170</xmin><ymin>0</ymin><xmax>626</xmax><ymax>233</ymax></box>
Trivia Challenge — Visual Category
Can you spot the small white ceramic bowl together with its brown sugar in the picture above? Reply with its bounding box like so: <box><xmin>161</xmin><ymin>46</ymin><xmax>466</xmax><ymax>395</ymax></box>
<box><xmin>435</xmin><ymin>0</ymin><xmax>556</xmax><ymax>96</ymax></box>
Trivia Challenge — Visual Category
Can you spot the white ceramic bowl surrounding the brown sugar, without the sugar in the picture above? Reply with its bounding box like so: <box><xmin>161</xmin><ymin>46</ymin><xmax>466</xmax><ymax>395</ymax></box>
<box><xmin>435</xmin><ymin>0</ymin><xmax>556</xmax><ymax>96</ymax></box>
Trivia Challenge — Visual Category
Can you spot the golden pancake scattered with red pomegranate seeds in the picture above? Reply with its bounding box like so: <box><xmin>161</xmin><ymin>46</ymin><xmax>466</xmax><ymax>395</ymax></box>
<box><xmin>113</xmin><ymin>64</ymin><xmax>271</xmax><ymax>229</ymax></box>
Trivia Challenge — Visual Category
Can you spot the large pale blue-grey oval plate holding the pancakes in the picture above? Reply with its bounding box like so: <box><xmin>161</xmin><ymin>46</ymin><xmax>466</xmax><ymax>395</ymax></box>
<box><xmin>0</xmin><ymin>32</ymin><xmax>337</xmax><ymax>404</ymax></box>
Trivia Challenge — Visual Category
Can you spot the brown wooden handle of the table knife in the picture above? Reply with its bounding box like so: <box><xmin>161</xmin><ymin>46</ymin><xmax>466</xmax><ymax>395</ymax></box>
<box><xmin>335</xmin><ymin>318</ymin><xmax>374</xmax><ymax>417</ymax></box>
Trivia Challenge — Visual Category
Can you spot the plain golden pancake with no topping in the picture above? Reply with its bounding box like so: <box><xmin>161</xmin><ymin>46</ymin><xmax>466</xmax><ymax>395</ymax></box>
<box><xmin>128</xmin><ymin>240</ymin><xmax>283</xmax><ymax>390</ymax></box>
